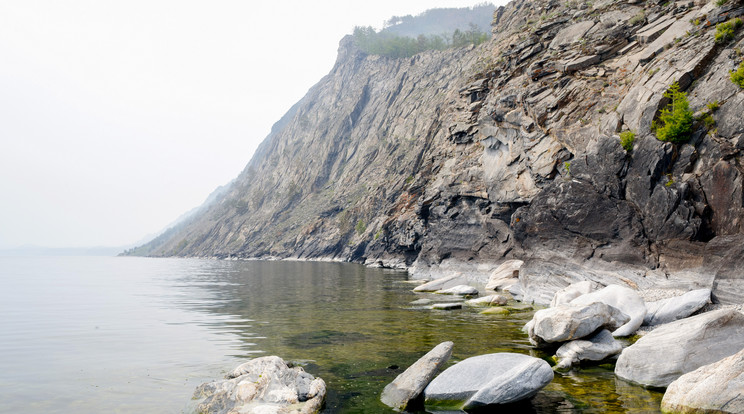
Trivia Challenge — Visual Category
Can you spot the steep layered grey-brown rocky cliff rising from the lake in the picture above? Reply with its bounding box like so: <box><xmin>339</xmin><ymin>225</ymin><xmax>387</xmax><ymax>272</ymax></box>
<box><xmin>132</xmin><ymin>0</ymin><xmax>744</xmax><ymax>303</ymax></box>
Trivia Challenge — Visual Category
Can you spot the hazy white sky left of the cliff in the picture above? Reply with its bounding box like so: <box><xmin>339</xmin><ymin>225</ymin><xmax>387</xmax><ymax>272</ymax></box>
<box><xmin>0</xmin><ymin>0</ymin><xmax>503</xmax><ymax>248</ymax></box>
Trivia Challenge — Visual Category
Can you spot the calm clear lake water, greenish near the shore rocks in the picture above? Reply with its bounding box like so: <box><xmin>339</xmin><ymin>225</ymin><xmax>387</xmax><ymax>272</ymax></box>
<box><xmin>0</xmin><ymin>257</ymin><xmax>661</xmax><ymax>413</ymax></box>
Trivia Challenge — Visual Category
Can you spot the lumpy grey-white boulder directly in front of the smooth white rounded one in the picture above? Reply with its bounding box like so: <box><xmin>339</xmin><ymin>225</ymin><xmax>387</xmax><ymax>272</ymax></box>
<box><xmin>525</xmin><ymin>302</ymin><xmax>630</xmax><ymax>346</ymax></box>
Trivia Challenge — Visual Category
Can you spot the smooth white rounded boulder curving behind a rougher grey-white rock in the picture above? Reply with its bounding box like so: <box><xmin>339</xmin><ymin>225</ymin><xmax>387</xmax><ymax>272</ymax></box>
<box><xmin>571</xmin><ymin>285</ymin><xmax>646</xmax><ymax>336</ymax></box>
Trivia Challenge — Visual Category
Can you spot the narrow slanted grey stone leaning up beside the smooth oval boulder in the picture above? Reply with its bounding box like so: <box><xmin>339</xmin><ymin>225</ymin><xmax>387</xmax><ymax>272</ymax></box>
<box><xmin>380</xmin><ymin>342</ymin><xmax>454</xmax><ymax>410</ymax></box>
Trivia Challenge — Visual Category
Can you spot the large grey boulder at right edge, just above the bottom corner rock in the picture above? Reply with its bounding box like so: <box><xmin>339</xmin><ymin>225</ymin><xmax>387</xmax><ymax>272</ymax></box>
<box><xmin>615</xmin><ymin>309</ymin><xmax>744</xmax><ymax>387</ymax></box>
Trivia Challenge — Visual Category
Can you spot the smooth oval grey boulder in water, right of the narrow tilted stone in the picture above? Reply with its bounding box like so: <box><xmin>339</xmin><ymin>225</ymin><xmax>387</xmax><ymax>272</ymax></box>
<box><xmin>424</xmin><ymin>353</ymin><xmax>553</xmax><ymax>410</ymax></box>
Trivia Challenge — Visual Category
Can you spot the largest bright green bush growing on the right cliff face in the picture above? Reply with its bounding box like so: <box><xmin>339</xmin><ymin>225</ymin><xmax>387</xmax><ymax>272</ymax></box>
<box><xmin>653</xmin><ymin>82</ymin><xmax>693</xmax><ymax>144</ymax></box>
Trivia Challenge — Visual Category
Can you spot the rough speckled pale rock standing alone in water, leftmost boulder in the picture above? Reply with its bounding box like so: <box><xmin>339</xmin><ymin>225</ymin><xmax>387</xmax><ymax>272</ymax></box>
<box><xmin>194</xmin><ymin>356</ymin><xmax>326</xmax><ymax>414</ymax></box>
